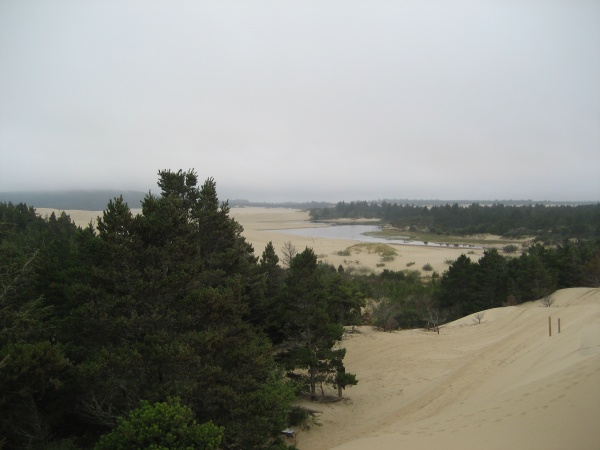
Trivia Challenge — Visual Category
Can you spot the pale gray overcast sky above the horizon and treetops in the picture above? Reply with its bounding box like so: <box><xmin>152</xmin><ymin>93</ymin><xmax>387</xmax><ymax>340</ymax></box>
<box><xmin>0</xmin><ymin>0</ymin><xmax>600</xmax><ymax>201</ymax></box>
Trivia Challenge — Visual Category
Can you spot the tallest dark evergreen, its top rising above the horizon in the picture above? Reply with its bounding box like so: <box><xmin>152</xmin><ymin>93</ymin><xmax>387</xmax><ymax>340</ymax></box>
<box><xmin>62</xmin><ymin>171</ymin><xmax>293</xmax><ymax>448</ymax></box>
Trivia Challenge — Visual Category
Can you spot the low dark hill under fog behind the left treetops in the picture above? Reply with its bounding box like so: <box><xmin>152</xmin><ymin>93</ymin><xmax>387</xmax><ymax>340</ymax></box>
<box><xmin>0</xmin><ymin>190</ymin><xmax>146</xmax><ymax>211</ymax></box>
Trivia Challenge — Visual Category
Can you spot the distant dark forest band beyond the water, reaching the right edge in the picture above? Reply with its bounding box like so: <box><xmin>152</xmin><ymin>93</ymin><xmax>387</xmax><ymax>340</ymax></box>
<box><xmin>310</xmin><ymin>202</ymin><xmax>600</xmax><ymax>241</ymax></box>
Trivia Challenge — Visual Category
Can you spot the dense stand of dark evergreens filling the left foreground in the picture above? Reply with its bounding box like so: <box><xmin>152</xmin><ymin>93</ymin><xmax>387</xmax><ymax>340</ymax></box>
<box><xmin>0</xmin><ymin>171</ymin><xmax>360</xmax><ymax>449</ymax></box>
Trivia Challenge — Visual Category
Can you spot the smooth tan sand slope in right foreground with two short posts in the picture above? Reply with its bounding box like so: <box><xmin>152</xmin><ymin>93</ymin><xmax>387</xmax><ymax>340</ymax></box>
<box><xmin>297</xmin><ymin>288</ymin><xmax>600</xmax><ymax>450</ymax></box>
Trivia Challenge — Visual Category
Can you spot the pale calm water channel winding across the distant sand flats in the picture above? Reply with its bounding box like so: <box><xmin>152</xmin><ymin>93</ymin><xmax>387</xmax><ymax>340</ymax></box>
<box><xmin>272</xmin><ymin>225</ymin><xmax>475</xmax><ymax>248</ymax></box>
